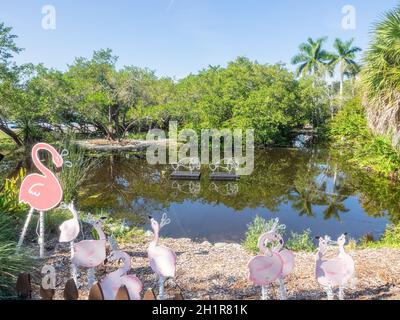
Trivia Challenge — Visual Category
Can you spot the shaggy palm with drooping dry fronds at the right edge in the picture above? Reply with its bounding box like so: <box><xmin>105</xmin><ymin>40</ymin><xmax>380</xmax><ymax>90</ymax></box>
<box><xmin>361</xmin><ymin>6</ymin><xmax>400</xmax><ymax>146</ymax></box>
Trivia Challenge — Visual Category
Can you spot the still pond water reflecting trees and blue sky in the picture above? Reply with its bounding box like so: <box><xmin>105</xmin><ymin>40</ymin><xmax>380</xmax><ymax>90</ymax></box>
<box><xmin>80</xmin><ymin>148</ymin><xmax>400</xmax><ymax>242</ymax></box>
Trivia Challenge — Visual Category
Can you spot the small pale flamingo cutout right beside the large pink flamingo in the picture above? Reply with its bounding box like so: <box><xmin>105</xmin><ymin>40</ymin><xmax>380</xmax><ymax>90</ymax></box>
<box><xmin>58</xmin><ymin>202</ymin><xmax>81</xmax><ymax>288</ymax></box>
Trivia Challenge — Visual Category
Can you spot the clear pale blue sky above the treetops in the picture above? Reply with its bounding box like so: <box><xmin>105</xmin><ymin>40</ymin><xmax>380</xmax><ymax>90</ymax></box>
<box><xmin>0</xmin><ymin>0</ymin><xmax>399</xmax><ymax>79</ymax></box>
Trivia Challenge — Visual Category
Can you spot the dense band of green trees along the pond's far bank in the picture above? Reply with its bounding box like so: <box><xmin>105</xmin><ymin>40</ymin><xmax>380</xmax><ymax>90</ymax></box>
<box><xmin>0</xmin><ymin>25</ymin><xmax>329</xmax><ymax>145</ymax></box>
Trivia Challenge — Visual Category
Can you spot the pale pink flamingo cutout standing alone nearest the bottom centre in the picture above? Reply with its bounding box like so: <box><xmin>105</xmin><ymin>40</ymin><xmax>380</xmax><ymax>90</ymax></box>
<box><xmin>147</xmin><ymin>213</ymin><xmax>176</xmax><ymax>300</ymax></box>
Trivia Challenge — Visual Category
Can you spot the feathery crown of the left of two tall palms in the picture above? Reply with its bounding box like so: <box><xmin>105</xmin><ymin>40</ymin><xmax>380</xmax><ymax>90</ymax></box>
<box><xmin>292</xmin><ymin>37</ymin><xmax>333</xmax><ymax>76</ymax></box>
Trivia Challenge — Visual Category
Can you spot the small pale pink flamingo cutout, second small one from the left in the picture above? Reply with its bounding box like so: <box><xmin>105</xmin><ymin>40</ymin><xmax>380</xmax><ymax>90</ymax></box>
<box><xmin>71</xmin><ymin>217</ymin><xmax>106</xmax><ymax>288</ymax></box>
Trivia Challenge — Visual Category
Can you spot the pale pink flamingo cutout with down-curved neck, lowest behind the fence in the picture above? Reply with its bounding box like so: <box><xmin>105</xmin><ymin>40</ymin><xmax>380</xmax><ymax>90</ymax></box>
<box><xmin>100</xmin><ymin>250</ymin><xmax>143</xmax><ymax>300</ymax></box>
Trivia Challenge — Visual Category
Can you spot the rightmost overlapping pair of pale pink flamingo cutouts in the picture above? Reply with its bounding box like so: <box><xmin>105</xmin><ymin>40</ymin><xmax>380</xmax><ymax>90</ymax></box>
<box><xmin>315</xmin><ymin>234</ymin><xmax>355</xmax><ymax>300</ymax></box>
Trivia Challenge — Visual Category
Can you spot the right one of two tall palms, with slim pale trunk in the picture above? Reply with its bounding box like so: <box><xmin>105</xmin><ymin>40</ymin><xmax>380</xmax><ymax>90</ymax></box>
<box><xmin>330</xmin><ymin>39</ymin><xmax>361</xmax><ymax>97</ymax></box>
